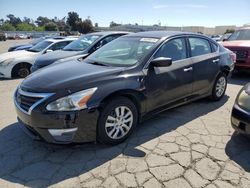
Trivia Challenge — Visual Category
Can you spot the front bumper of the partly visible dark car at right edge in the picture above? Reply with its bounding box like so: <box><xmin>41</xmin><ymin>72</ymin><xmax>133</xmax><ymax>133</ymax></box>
<box><xmin>231</xmin><ymin>104</ymin><xmax>250</xmax><ymax>135</ymax></box>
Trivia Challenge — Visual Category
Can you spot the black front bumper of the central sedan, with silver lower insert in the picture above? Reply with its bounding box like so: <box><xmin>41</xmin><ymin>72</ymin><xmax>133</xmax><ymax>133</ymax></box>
<box><xmin>15</xmin><ymin>100</ymin><xmax>99</xmax><ymax>144</ymax></box>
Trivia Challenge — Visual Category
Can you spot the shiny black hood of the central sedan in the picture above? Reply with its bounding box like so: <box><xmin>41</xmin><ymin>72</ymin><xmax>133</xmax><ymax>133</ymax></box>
<box><xmin>21</xmin><ymin>60</ymin><xmax>125</xmax><ymax>93</ymax></box>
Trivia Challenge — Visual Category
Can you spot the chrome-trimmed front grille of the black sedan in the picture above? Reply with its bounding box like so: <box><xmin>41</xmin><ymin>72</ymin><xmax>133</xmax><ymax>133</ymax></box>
<box><xmin>15</xmin><ymin>88</ymin><xmax>52</xmax><ymax>114</ymax></box>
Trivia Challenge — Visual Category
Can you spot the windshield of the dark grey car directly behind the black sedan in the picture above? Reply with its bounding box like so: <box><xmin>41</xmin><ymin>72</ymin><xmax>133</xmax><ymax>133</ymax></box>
<box><xmin>63</xmin><ymin>35</ymin><xmax>101</xmax><ymax>51</ymax></box>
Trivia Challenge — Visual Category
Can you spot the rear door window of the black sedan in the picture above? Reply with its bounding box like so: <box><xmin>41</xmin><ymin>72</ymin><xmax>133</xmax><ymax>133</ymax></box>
<box><xmin>189</xmin><ymin>38</ymin><xmax>211</xmax><ymax>56</ymax></box>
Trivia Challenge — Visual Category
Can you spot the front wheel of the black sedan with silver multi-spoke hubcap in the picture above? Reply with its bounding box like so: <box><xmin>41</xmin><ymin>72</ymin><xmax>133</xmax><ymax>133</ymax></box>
<box><xmin>97</xmin><ymin>97</ymin><xmax>138</xmax><ymax>145</ymax></box>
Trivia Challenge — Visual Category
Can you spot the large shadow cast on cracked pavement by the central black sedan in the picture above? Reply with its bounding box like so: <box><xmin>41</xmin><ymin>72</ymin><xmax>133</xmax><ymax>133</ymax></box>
<box><xmin>0</xmin><ymin>96</ymin><xmax>229</xmax><ymax>187</ymax></box>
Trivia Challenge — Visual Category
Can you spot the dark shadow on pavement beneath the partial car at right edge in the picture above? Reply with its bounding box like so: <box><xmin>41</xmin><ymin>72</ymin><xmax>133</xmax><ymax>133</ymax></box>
<box><xmin>226</xmin><ymin>132</ymin><xmax>250</xmax><ymax>172</ymax></box>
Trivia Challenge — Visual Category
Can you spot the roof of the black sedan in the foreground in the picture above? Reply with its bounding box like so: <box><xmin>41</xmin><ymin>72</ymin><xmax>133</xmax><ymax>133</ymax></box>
<box><xmin>123</xmin><ymin>31</ymin><xmax>205</xmax><ymax>39</ymax></box>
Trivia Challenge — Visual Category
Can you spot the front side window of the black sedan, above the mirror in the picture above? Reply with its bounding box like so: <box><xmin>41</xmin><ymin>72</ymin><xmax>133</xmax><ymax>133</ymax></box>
<box><xmin>154</xmin><ymin>38</ymin><xmax>187</xmax><ymax>61</ymax></box>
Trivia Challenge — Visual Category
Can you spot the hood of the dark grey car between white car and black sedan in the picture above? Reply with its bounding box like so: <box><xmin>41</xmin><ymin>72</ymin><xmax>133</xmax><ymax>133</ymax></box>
<box><xmin>35</xmin><ymin>50</ymin><xmax>82</xmax><ymax>67</ymax></box>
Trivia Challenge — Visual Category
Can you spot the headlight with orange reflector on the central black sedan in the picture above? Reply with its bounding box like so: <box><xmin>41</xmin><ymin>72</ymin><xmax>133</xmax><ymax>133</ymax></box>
<box><xmin>46</xmin><ymin>87</ymin><xmax>97</xmax><ymax>111</ymax></box>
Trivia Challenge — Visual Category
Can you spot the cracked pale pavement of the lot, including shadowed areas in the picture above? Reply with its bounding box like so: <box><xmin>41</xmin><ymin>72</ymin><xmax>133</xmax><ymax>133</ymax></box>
<box><xmin>0</xmin><ymin>41</ymin><xmax>250</xmax><ymax>188</ymax></box>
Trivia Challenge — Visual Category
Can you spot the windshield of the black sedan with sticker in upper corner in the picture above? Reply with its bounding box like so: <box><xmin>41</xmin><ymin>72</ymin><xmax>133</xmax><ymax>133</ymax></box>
<box><xmin>86</xmin><ymin>37</ymin><xmax>159</xmax><ymax>66</ymax></box>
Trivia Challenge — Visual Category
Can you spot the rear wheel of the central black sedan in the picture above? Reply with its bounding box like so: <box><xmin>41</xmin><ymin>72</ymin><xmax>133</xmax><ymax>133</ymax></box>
<box><xmin>210</xmin><ymin>73</ymin><xmax>227</xmax><ymax>101</ymax></box>
